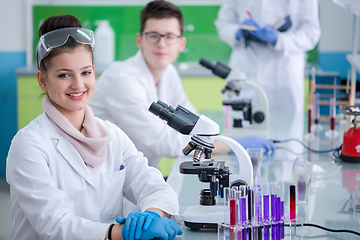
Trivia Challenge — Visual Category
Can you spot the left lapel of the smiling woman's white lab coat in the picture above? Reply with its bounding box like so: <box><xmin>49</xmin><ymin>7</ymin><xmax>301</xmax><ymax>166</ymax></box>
<box><xmin>40</xmin><ymin>113</ymin><xmax>93</xmax><ymax>185</ymax></box>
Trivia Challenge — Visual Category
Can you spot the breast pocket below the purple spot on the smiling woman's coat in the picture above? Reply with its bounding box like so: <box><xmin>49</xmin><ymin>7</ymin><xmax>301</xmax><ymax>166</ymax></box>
<box><xmin>102</xmin><ymin>170</ymin><xmax>126</xmax><ymax>218</ymax></box>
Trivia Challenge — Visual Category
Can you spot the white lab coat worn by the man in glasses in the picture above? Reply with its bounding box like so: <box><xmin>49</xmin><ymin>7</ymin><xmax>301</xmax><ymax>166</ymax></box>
<box><xmin>89</xmin><ymin>50</ymin><xmax>195</xmax><ymax>167</ymax></box>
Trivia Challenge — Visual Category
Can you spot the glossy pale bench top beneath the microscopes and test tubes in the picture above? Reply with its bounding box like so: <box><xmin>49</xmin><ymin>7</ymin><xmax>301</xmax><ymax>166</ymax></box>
<box><xmin>167</xmin><ymin>111</ymin><xmax>360</xmax><ymax>240</ymax></box>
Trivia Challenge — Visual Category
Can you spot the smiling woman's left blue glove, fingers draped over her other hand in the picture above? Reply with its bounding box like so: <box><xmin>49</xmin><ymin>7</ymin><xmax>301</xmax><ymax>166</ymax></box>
<box><xmin>116</xmin><ymin>211</ymin><xmax>160</xmax><ymax>240</ymax></box>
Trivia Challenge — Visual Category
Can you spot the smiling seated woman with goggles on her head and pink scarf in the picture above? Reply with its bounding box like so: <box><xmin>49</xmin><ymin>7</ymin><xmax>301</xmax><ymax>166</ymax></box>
<box><xmin>6</xmin><ymin>15</ymin><xmax>182</xmax><ymax>240</ymax></box>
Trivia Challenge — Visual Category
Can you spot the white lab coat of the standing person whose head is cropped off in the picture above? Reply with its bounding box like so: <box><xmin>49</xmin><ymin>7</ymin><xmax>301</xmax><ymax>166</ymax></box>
<box><xmin>215</xmin><ymin>0</ymin><xmax>321</xmax><ymax>111</ymax></box>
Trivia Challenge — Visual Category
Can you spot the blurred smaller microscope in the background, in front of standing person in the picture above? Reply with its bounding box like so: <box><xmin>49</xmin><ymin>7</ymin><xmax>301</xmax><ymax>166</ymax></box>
<box><xmin>199</xmin><ymin>58</ymin><xmax>269</xmax><ymax>138</ymax></box>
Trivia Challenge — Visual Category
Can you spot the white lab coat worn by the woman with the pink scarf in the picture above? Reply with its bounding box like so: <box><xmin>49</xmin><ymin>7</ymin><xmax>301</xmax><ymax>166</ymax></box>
<box><xmin>6</xmin><ymin>114</ymin><xmax>178</xmax><ymax>240</ymax></box>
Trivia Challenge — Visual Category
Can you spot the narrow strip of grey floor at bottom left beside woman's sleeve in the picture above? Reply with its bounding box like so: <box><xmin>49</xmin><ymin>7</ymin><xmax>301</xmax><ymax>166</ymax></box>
<box><xmin>0</xmin><ymin>177</ymin><xmax>11</xmax><ymax>240</ymax></box>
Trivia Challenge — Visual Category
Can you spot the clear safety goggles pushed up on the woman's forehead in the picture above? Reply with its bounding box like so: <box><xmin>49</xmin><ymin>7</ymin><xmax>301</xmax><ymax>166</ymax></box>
<box><xmin>37</xmin><ymin>27</ymin><xmax>95</xmax><ymax>69</ymax></box>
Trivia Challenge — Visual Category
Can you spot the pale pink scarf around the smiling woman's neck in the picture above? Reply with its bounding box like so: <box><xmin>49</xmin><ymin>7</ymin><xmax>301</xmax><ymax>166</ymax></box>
<box><xmin>42</xmin><ymin>96</ymin><xmax>111</xmax><ymax>167</ymax></box>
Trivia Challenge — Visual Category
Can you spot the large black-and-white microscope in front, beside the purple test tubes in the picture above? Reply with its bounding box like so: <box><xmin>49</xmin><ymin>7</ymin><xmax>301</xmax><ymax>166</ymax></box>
<box><xmin>149</xmin><ymin>101</ymin><xmax>253</xmax><ymax>231</ymax></box>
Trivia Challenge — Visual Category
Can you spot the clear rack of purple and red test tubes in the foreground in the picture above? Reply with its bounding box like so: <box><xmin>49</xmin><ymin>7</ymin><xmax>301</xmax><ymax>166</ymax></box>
<box><xmin>218</xmin><ymin>182</ymin><xmax>303</xmax><ymax>240</ymax></box>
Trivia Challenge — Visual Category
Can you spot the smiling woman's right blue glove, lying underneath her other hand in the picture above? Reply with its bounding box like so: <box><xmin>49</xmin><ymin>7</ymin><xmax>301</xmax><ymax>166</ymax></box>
<box><xmin>140</xmin><ymin>217</ymin><xmax>183</xmax><ymax>240</ymax></box>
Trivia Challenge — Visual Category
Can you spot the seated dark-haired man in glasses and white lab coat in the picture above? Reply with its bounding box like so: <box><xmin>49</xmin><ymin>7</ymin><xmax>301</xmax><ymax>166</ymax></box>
<box><xmin>89</xmin><ymin>1</ymin><xmax>274</xmax><ymax>166</ymax></box>
